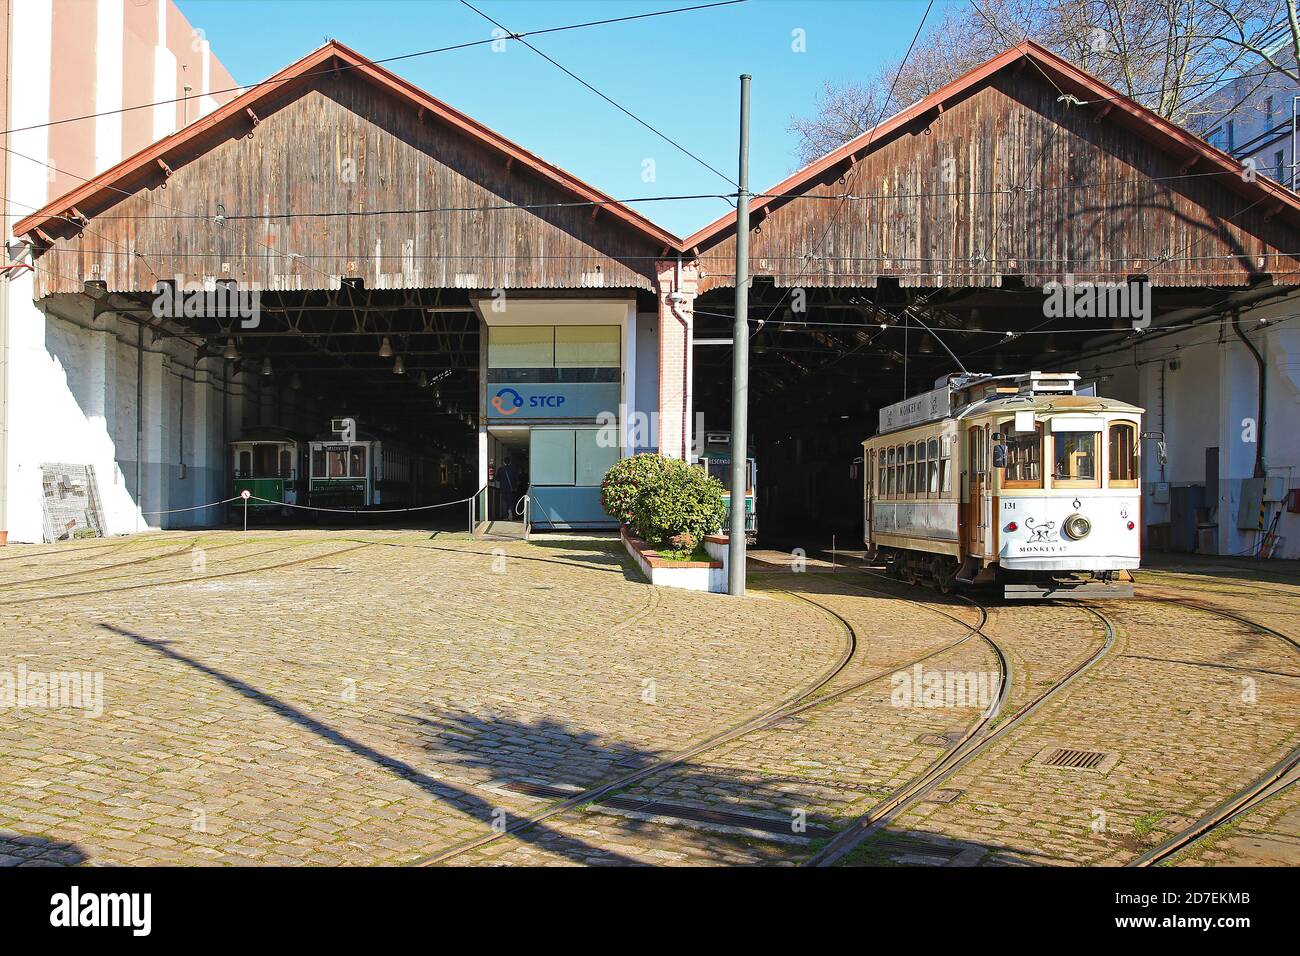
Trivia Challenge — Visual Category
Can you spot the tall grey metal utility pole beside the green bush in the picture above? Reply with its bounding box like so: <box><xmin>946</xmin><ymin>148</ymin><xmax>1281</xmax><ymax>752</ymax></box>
<box><xmin>727</xmin><ymin>73</ymin><xmax>750</xmax><ymax>597</ymax></box>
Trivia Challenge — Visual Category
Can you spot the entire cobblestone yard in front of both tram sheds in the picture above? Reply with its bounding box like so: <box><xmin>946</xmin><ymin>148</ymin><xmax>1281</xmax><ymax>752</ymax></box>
<box><xmin>0</xmin><ymin>532</ymin><xmax>1300</xmax><ymax>865</ymax></box>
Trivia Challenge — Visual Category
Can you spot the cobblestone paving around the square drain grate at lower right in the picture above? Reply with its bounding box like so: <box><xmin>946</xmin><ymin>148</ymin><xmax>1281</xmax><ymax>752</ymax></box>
<box><xmin>855</xmin><ymin>572</ymin><xmax>1300</xmax><ymax>865</ymax></box>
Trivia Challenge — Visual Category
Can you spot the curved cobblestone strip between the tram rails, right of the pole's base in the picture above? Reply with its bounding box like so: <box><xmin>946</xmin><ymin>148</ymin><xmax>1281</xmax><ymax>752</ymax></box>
<box><xmin>462</xmin><ymin>574</ymin><xmax>997</xmax><ymax>865</ymax></box>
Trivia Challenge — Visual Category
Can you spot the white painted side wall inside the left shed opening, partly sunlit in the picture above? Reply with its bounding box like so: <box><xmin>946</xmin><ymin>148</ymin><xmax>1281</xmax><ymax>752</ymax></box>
<box><xmin>9</xmin><ymin>295</ymin><xmax>320</xmax><ymax>541</ymax></box>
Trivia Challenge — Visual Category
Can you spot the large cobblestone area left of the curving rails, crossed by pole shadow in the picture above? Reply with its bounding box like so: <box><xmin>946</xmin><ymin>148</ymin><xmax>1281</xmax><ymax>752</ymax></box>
<box><xmin>0</xmin><ymin>532</ymin><xmax>845</xmax><ymax>865</ymax></box>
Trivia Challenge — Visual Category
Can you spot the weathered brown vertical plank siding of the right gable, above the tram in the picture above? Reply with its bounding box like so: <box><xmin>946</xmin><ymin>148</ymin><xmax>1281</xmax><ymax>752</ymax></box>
<box><xmin>699</xmin><ymin>75</ymin><xmax>1300</xmax><ymax>287</ymax></box>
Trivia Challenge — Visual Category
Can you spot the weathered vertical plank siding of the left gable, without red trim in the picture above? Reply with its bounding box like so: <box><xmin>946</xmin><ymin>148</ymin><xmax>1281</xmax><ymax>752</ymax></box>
<box><xmin>38</xmin><ymin>73</ymin><xmax>663</xmax><ymax>295</ymax></box>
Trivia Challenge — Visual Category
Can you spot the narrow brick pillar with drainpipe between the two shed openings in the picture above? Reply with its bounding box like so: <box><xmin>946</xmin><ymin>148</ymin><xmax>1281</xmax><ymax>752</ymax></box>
<box><xmin>655</xmin><ymin>259</ymin><xmax>699</xmax><ymax>460</ymax></box>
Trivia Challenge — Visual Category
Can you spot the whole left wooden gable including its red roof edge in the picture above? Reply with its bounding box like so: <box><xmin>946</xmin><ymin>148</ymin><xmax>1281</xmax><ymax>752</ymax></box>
<box><xmin>22</xmin><ymin>42</ymin><xmax>679</xmax><ymax>294</ymax></box>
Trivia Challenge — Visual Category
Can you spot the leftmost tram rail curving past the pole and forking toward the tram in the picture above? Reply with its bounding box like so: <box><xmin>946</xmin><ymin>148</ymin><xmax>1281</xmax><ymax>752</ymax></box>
<box><xmin>415</xmin><ymin>574</ymin><xmax>1010</xmax><ymax>866</ymax></box>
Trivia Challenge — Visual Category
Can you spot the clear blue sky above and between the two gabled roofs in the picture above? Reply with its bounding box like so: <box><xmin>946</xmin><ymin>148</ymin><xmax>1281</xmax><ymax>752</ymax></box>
<box><xmin>177</xmin><ymin>0</ymin><xmax>943</xmax><ymax>235</ymax></box>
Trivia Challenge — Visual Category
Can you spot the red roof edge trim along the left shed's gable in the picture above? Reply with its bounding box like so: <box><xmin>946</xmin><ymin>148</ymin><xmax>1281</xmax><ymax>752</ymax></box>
<box><xmin>13</xmin><ymin>40</ymin><xmax>681</xmax><ymax>251</ymax></box>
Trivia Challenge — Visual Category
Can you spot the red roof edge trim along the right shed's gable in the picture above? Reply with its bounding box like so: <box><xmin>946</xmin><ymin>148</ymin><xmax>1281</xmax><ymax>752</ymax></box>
<box><xmin>681</xmin><ymin>40</ymin><xmax>1300</xmax><ymax>252</ymax></box>
